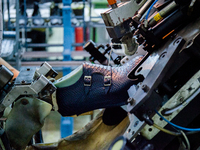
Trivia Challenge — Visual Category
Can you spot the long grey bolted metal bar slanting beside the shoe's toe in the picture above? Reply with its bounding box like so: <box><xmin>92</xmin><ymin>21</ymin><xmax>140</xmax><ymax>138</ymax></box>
<box><xmin>128</xmin><ymin>37</ymin><xmax>184</xmax><ymax>113</ymax></box>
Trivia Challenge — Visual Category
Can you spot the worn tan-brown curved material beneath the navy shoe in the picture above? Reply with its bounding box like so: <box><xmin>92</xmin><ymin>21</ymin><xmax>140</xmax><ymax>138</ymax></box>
<box><xmin>27</xmin><ymin>112</ymin><xmax>130</xmax><ymax>150</ymax></box>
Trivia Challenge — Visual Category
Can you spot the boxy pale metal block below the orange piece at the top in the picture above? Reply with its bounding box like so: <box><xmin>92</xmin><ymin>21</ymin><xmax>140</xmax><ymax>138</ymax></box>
<box><xmin>101</xmin><ymin>0</ymin><xmax>146</xmax><ymax>39</ymax></box>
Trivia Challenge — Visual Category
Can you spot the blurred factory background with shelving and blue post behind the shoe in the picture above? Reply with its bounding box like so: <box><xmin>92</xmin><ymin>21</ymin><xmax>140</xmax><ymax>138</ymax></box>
<box><xmin>1</xmin><ymin>0</ymin><xmax>110</xmax><ymax>142</ymax></box>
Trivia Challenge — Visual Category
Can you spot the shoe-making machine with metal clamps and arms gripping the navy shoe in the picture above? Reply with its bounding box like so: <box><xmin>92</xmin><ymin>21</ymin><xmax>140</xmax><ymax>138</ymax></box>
<box><xmin>0</xmin><ymin>0</ymin><xmax>200</xmax><ymax>150</ymax></box>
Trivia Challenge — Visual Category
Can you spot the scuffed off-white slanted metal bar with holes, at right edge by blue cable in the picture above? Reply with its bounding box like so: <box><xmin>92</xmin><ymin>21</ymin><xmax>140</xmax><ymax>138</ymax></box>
<box><xmin>141</xmin><ymin>71</ymin><xmax>200</xmax><ymax>140</ymax></box>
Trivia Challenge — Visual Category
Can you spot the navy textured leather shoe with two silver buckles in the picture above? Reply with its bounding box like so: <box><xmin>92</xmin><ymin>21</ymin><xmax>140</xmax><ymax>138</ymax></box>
<box><xmin>56</xmin><ymin>56</ymin><xmax>143</xmax><ymax>116</ymax></box>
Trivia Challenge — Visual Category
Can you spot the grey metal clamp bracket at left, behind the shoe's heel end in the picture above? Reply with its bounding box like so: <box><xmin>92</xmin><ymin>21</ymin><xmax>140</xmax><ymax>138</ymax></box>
<box><xmin>0</xmin><ymin>62</ymin><xmax>57</xmax><ymax>112</ymax></box>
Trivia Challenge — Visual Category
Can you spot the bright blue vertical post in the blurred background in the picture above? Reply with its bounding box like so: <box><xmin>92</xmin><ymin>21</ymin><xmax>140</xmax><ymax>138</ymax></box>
<box><xmin>60</xmin><ymin>0</ymin><xmax>74</xmax><ymax>138</ymax></box>
